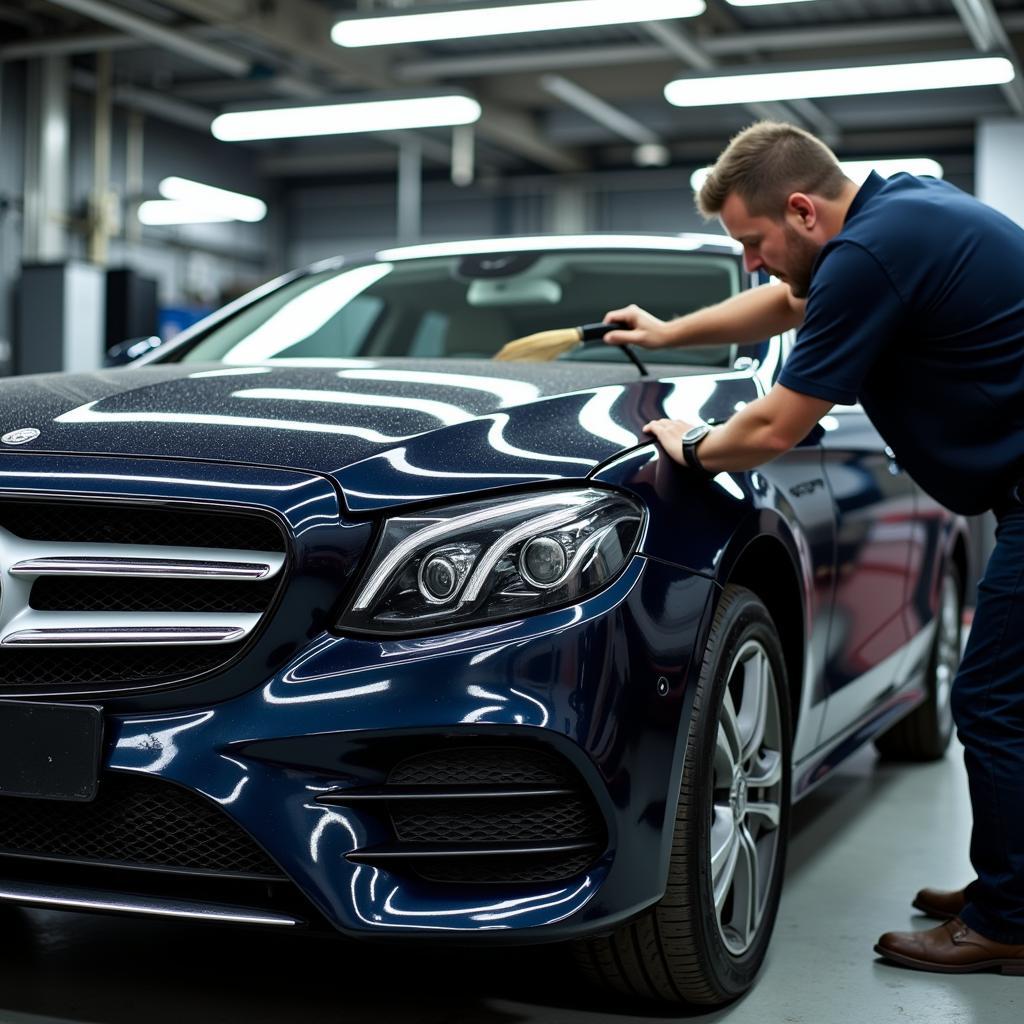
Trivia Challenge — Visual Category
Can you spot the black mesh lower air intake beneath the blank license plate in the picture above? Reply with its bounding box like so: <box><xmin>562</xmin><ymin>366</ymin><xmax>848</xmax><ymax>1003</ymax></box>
<box><xmin>0</xmin><ymin>773</ymin><xmax>284</xmax><ymax>879</ymax></box>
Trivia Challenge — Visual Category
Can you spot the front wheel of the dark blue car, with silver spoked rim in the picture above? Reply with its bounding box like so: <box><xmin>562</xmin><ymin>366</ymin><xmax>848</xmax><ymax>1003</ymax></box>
<box><xmin>573</xmin><ymin>586</ymin><xmax>792</xmax><ymax>1006</ymax></box>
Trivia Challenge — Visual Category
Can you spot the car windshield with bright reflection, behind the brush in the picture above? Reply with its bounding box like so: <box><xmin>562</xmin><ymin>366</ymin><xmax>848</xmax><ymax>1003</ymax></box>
<box><xmin>167</xmin><ymin>251</ymin><xmax>739</xmax><ymax>367</ymax></box>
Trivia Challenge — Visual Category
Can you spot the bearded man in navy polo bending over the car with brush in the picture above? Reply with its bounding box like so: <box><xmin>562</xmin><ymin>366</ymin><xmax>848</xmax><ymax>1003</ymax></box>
<box><xmin>604</xmin><ymin>122</ymin><xmax>1024</xmax><ymax>974</ymax></box>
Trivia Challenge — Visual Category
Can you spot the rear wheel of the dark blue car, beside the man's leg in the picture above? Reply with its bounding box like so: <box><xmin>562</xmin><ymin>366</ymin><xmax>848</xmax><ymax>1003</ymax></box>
<box><xmin>874</xmin><ymin>563</ymin><xmax>964</xmax><ymax>761</ymax></box>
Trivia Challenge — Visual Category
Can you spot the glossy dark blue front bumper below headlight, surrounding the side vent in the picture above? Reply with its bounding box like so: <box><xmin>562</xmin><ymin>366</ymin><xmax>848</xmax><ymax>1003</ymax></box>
<box><xmin>108</xmin><ymin>557</ymin><xmax>712</xmax><ymax>939</ymax></box>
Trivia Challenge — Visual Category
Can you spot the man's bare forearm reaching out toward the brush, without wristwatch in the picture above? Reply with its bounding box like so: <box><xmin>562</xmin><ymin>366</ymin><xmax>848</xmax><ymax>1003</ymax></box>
<box><xmin>666</xmin><ymin>285</ymin><xmax>804</xmax><ymax>347</ymax></box>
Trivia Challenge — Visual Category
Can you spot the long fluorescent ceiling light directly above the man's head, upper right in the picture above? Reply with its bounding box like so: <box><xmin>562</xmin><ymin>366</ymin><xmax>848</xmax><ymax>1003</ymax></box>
<box><xmin>665</xmin><ymin>57</ymin><xmax>1014</xmax><ymax>106</ymax></box>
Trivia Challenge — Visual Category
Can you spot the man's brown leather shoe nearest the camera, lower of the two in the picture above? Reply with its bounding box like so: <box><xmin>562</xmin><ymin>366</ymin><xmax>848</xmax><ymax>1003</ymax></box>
<box><xmin>874</xmin><ymin>918</ymin><xmax>1024</xmax><ymax>975</ymax></box>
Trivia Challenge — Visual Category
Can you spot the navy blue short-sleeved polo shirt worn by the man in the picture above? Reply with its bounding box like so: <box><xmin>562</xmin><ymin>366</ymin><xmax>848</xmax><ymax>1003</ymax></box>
<box><xmin>779</xmin><ymin>174</ymin><xmax>1024</xmax><ymax>514</ymax></box>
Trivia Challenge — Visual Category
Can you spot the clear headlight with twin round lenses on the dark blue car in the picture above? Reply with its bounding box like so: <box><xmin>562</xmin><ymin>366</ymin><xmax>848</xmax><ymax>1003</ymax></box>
<box><xmin>338</xmin><ymin>487</ymin><xmax>644</xmax><ymax>634</ymax></box>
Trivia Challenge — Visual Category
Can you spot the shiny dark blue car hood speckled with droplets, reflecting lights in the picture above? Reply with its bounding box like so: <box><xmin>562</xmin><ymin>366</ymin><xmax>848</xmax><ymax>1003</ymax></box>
<box><xmin>0</xmin><ymin>359</ymin><xmax>756</xmax><ymax>509</ymax></box>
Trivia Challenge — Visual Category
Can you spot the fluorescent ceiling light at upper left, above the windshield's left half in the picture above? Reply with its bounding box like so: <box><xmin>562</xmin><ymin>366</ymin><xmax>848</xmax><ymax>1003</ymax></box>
<box><xmin>210</xmin><ymin>95</ymin><xmax>480</xmax><ymax>142</ymax></box>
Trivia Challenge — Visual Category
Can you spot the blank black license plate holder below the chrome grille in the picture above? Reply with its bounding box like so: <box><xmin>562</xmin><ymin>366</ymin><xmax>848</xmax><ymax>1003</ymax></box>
<box><xmin>0</xmin><ymin>700</ymin><xmax>103</xmax><ymax>801</ymax></box>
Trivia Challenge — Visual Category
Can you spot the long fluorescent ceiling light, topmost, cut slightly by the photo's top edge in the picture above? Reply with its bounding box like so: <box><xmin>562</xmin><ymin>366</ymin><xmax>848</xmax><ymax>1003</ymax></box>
<box><xmin>331</xmin><ymin>0</ymin><xmax>705</xmax><ymax>46</ymax></box>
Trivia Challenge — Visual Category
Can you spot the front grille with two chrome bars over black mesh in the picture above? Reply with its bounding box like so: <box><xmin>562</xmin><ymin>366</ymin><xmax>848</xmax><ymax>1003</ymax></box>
<box><xmin>0</xmin><ymin>502</ymin><xmax>285</xmax><ymax>692</ymax></box>
